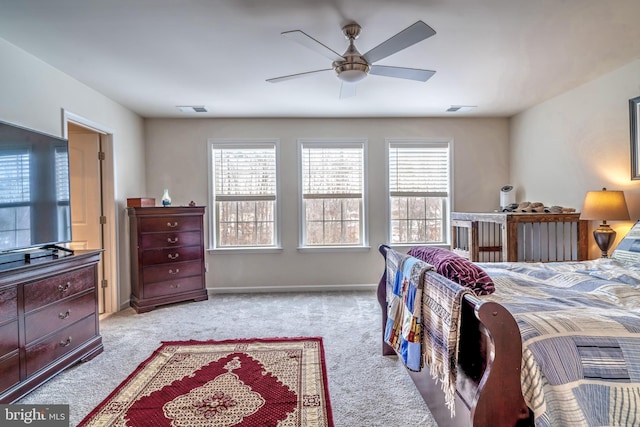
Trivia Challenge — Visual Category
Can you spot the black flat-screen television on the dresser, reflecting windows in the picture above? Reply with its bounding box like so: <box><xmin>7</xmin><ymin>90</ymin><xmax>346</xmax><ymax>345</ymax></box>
<box><xmin>0</xmin><ymin>121</ymin><xmax>71</xmax><ymax>251</ymax></box>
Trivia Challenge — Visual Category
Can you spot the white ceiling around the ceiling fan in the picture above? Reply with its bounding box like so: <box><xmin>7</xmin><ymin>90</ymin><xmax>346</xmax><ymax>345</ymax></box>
<box><xmin>0</xmin><ymin>0</ymin><xmax>640</xmax><ymax>117</ymax></box>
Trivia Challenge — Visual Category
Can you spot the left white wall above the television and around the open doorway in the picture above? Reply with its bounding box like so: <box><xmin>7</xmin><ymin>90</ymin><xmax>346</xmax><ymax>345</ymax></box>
<box><xmin>0</xmin><ymin>39</ymin><xmax>146</xmax><ymax>310</ymax></box>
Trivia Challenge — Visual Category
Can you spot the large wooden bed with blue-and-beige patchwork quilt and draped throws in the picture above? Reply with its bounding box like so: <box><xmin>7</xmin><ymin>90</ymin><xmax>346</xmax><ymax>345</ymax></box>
<box><xmin>378</xmin><ymin>222</ymin><xmax>640</xmax><ymax>427</ymax></box>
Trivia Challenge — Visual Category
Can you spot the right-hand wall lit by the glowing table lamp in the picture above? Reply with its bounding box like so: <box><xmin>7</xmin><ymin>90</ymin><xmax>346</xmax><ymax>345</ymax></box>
<box><xmin>510</xmin><ymin>60</ymin><xmax>640</xmax><ymax>258</ymax></box>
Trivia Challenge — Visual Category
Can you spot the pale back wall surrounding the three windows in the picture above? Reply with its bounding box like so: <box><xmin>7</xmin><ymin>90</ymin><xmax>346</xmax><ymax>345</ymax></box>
<box><xmin>145</xmin><ymin>118</ymin><xmax>509</xmax><ymax>291</ymax></box>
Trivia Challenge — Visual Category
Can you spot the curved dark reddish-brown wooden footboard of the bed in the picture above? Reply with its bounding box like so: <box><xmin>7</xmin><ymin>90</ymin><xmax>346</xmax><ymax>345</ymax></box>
<box><xmin>378</xmin><ymin>245</ymin><xmax>533</xmax><ymax>427</ymax></box>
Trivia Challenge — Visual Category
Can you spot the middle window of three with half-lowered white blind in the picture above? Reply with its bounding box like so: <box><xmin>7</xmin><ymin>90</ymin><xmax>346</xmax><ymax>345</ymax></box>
<box><xmin>299</xmin><ymin>140</ymin><xmax>366</xmax><ymax>247</ymax></box>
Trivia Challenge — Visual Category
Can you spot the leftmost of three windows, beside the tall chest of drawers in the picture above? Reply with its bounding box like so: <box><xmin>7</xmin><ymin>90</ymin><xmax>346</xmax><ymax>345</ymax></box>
<box><xmin>209</xmin><ymin>140</ymin><xmax>279</xmax><ymax>248</ymax></box>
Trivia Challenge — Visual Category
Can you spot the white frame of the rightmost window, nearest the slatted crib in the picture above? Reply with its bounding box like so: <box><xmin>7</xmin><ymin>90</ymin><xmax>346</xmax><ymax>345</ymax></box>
<box><xmin>385</xmin><ymin>138</ymin><xmax>455</xmax><ymax>248</ymax></box>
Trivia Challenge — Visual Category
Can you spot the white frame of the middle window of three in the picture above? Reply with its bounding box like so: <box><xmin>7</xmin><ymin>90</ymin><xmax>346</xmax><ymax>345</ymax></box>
<box><xmin>297</xmin><ymin>138</ymin><xmax>369</xmax><ymax>252</ymax></box>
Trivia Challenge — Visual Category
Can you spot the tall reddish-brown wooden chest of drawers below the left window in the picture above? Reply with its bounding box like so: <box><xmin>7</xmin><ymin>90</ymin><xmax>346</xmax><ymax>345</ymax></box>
<box><xmin>128</xmin><ymin>206</ymin><xmax>207</xmax><ymax>313</ymax></box>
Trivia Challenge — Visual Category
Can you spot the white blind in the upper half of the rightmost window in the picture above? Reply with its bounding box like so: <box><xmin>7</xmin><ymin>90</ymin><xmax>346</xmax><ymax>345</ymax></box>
<box><xmin>389</xmin><ymin>143</ymin><xmax>449</xmax><ymax>197</ymax></box>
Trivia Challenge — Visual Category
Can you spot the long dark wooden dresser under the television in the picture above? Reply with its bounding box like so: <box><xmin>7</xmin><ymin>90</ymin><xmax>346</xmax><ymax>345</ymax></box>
<box><xmin>0</xmin><ymin>251</ymin><xmax>103</xmax><ymax>403</ymax></box>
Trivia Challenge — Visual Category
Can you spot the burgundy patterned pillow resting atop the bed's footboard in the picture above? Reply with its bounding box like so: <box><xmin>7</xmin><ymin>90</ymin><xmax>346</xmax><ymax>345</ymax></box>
<box><xmin>407</xmin><ymin>246</ymin><xmax>496</xmax><ymax>295</ymax></box>
